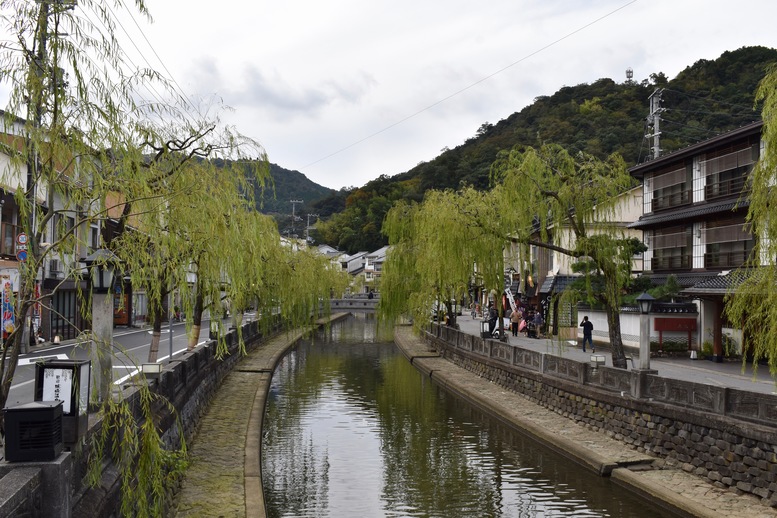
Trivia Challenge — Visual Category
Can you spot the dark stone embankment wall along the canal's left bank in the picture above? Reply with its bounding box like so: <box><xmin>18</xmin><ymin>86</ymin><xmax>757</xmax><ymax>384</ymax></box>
<box><xmin>0</xmin><ymin>322</ymin><xmax>280</xmax><ymax>518</ymax></box>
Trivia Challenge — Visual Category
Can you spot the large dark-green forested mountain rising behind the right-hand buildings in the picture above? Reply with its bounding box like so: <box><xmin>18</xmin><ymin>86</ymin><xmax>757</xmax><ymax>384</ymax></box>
<box><xmin>313</xmin><ymin>47</ymin><xmax>777</xmax><ymax>252</ymax></box>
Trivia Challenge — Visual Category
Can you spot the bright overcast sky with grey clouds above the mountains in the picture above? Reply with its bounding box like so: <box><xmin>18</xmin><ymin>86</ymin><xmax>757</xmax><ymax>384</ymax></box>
<box><xmin>57</xmin><ymin>0</ymin><xmax>777</xmax><ymax>189</ymax></box>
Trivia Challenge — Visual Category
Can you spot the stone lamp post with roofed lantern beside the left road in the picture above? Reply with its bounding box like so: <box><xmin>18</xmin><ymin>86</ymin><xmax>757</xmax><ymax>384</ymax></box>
<box><xmin>84</xmin><ymin>248</ymin><xmax>119</xmax><ymax>402</ymax></box>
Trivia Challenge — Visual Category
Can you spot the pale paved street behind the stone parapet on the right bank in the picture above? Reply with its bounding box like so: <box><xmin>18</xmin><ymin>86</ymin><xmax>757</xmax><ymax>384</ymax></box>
<box><xmin>456</xmin><ymin>315</ymin><xmax>777</xmax><ymax>394</ymax></box>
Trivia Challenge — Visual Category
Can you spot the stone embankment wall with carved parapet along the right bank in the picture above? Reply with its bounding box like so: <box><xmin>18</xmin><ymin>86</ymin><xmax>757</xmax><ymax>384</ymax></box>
<box><xmin>426</xmin><ymin>325</ymin><xmax>777</xmax><ymax>507</ymax></box>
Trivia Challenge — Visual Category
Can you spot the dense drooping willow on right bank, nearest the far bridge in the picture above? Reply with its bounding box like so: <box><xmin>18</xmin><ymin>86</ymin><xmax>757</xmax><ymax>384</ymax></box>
<box><xmin>379</xmin><ymin>189</ymin><xmax>504</xmax><ymax>334</ymax></box>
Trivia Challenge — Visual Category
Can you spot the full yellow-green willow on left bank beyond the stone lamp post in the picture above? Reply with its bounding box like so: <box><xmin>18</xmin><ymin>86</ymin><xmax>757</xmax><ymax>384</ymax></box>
<box><xmin>112</xmin><ymin>150</ymin><xmax>268</xmax><ymax>362</ymax></box>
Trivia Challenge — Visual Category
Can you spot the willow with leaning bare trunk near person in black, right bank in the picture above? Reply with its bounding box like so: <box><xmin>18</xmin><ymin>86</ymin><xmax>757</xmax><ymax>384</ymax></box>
<box><xmin>493</xmin><ymin>145</ymin><xmax>638</xmax><ymax>368</ymax></box>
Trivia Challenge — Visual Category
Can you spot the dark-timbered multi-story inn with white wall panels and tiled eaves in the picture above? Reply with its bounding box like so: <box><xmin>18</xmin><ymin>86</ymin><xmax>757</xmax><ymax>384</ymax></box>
<box><xmin>629</xmin><ymin>121</ymin><xmax>763</xmax><ymax>357</ymax></box>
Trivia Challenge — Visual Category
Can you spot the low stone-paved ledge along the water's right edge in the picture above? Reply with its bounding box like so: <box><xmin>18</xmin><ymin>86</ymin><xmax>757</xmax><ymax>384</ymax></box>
<box><xmin>394</xmin><ymin>323</ymin><xmax>777</xmax><ymax>518</ymax></box>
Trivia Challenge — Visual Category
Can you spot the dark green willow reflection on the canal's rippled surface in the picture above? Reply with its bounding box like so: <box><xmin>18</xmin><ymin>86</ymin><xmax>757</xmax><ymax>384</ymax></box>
<box><xmin>377</xmin><ymin>356</ymin><xmax>501</xmax><ymax>516</ymax></box>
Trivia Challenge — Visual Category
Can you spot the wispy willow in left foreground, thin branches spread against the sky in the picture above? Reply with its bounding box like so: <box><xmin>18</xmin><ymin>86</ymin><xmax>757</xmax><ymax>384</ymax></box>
<box><xmin>0</xmin><ymin>0</ymin><xmax>263</xmax><ymax>516</ymax></box>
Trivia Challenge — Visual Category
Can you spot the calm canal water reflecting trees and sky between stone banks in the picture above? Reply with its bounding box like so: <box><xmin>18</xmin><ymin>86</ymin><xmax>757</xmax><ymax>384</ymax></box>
<box><xmin>262</xmin><ymin>314</ymin><xmax>669</xmax><ymax>518</ymax></box>
